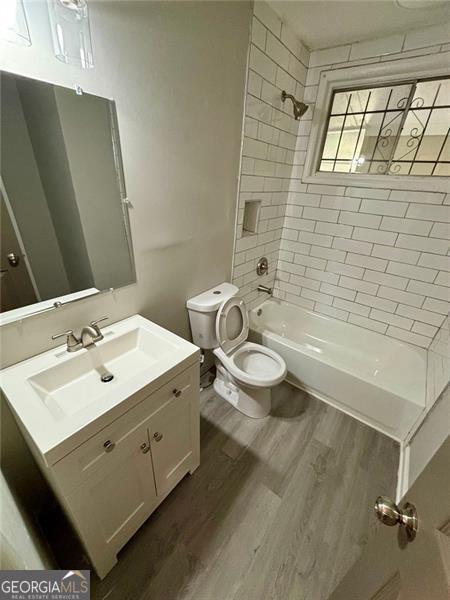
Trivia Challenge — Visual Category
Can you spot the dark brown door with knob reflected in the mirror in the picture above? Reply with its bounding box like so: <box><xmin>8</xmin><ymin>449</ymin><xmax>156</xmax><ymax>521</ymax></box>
<box><xmin>0</xmin><ymin>194</ymin><xmax>37</xmax><ymax>312</ymax></box>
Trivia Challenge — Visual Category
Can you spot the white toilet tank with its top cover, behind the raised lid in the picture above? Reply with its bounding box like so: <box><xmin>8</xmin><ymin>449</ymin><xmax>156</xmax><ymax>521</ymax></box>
<box><xmin>186</xmin><ymin>282</ymin><xmax>239</xmax><ymax>350</ymax></box>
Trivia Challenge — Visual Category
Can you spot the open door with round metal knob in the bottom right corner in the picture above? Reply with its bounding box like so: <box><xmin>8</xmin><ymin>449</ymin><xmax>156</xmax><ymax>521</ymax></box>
<box><xmin>329</xmin><ymin>438</ymin><xmax>450</xmax><ymax>600</ymax></box>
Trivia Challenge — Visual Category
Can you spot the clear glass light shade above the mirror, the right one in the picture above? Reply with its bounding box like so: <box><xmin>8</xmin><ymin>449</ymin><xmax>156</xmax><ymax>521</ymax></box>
<box><xmin>47</xmin><ymin>0</ymin><xmax>94</xmax><ymax>69</ymax></box>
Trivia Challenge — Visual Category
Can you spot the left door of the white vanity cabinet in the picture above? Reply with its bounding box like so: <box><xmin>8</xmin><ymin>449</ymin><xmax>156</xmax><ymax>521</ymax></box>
<box><xmin>69</xmin><ymin>419</ymin><xmax>158</xmax><ymax>563</ymax></box>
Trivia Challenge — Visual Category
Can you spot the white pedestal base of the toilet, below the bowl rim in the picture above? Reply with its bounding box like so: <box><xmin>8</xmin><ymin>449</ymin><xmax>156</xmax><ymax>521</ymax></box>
<box><xmin>214</xmin><ymin>364</ymin><xmax>271</xmax><ymax>419</ymax></box>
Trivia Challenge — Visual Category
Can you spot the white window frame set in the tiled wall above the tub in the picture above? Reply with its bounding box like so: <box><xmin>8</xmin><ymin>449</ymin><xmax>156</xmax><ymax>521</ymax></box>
<box><xmin>302</xmin><ymin>52</ymin><xmax>450</xmax><ymax>192</ymax></box>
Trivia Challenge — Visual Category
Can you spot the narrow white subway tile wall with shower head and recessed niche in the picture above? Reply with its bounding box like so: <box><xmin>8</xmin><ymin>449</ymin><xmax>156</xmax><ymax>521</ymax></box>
<box><xmin>233</xmin><ymin>2</ymin><xmax>310</xmax><ymax>308</ymax></box>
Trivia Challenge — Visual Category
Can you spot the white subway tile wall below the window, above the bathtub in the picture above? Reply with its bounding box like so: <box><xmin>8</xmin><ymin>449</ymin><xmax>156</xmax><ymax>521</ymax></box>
<box><xmin>275</xmin><ymin>180</ymin><xmax>450</xmax><ymax>348</ymax></box>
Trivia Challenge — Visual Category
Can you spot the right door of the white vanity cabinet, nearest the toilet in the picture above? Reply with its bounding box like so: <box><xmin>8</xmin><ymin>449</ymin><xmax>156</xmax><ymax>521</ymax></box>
<box><xmin>149</xmin><ymin>390</ymin><xmax>194</xmax><ymax>497</ymax></box>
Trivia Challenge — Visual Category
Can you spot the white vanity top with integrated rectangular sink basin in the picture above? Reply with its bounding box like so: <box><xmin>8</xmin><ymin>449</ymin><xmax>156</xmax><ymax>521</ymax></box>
<box><xmin>0</xmin><ymin>315</ymin><xmax>199</xmax><ymax>464</ymax></box>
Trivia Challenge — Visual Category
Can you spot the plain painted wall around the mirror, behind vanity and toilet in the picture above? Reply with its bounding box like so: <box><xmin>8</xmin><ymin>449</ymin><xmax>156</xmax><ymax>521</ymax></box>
<box><xmin>0</xmin><ymin>1</ymin><xmax>251</xmax><ymax>365</ymax></box>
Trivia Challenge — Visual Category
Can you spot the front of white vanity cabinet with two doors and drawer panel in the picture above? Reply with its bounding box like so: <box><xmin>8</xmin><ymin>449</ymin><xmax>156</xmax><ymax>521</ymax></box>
<box><xmin>42</xmin><ymin>365</ymin><xmax>199</xmax><ymax>578</ymax></box>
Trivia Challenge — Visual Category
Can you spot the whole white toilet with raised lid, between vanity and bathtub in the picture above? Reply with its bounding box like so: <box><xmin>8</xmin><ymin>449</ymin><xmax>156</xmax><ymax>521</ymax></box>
<box><xmin>186</xmin><ymin>283</ymin><xmax>286</xmax><ymax>419</ymax></box>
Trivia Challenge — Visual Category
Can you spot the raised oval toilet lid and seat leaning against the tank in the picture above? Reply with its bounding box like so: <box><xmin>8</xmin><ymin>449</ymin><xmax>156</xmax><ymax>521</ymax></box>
<box><xmin>216</xmin><ymin>296</ymin><xmax>248</xmax><ymax>354</ymax></box>
